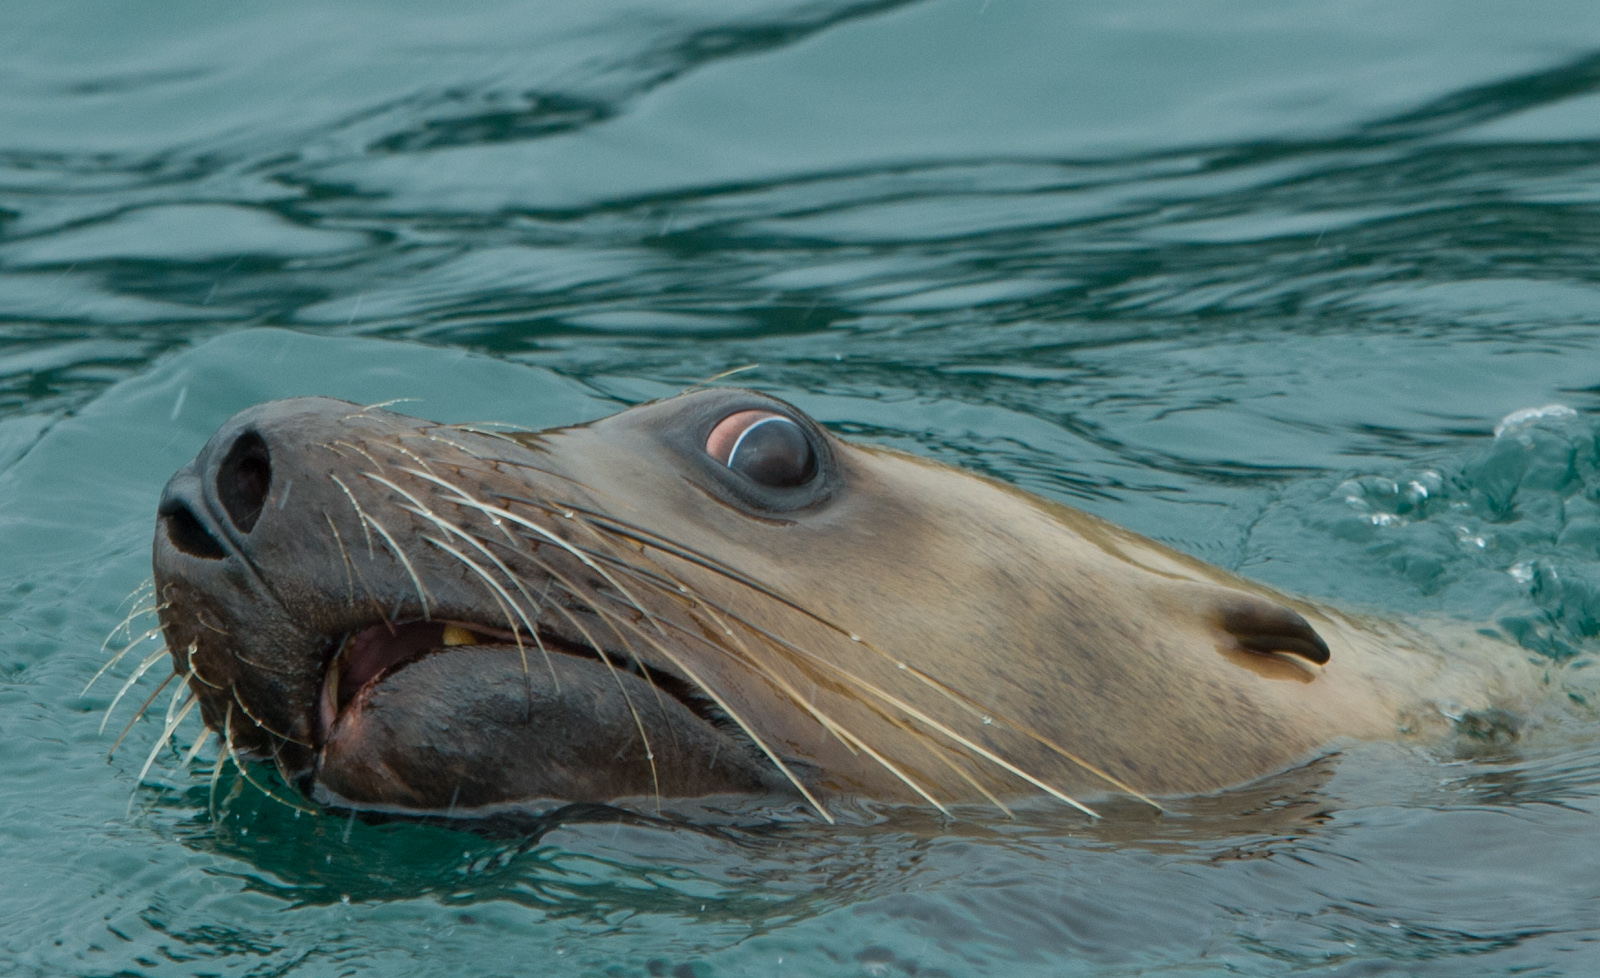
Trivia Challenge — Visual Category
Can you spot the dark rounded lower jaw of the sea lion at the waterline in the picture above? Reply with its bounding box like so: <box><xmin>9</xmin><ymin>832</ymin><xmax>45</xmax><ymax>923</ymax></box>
<box><xmin>312</xmin><ymin>645</ymin><xmax>787</xmax><ymax>813</ymax></box>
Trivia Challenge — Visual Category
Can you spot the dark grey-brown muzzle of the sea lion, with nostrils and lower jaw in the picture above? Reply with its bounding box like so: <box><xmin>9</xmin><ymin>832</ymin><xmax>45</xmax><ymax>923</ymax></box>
<box><xmin>155</xmin><ymin>399</ymin><xmax>800</xmax><ymax>810</ymax></box>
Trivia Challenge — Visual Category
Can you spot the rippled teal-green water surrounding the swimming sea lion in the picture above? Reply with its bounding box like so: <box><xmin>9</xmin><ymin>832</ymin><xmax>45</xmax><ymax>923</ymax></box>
<box><xmin>0</xmin><ymin>0</ymin><xmax>1600</xmax><ymax>978</ymax></box>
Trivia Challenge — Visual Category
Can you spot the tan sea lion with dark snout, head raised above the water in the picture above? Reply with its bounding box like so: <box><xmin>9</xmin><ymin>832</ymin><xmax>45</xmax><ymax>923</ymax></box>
<box><xmin>154</xmin><ymin>389</ymin><xmax>1525</xmax><ymax>818</ymax></box>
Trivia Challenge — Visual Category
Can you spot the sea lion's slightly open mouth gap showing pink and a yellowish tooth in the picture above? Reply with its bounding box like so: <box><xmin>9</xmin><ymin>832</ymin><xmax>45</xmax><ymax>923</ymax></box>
<box><xmin>318</xmin><ymin>621</ymin><xmax>738</xmax><ymax>741</ymax></box>
